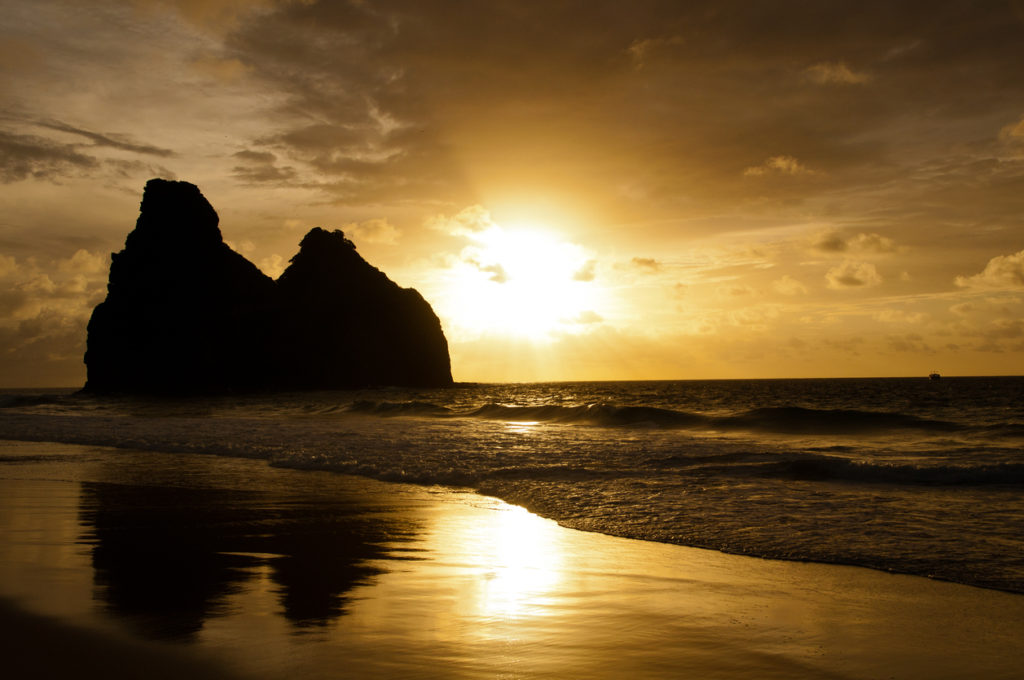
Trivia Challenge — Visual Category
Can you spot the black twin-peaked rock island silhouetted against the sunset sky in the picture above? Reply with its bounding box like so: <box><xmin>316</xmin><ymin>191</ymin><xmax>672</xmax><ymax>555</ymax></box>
<box><xmin>85</xmin><ymin>179</ymin><xmax>452</xmax><ymax>394</ymax></box>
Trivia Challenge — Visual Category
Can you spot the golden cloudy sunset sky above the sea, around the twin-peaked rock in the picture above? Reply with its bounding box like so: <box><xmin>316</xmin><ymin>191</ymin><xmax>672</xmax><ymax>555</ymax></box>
<box><xmin>0</xmin><ymin>0</ymin><xmax>1024</xmax><ymax>386</ymax></box>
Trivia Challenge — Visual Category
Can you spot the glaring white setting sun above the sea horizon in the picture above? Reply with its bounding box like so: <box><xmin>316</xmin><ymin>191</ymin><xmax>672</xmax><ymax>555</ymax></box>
<box><xmin>439</xmin><ymin>223</ymin><xmax>600</xmax><ymax>340</ymax></box>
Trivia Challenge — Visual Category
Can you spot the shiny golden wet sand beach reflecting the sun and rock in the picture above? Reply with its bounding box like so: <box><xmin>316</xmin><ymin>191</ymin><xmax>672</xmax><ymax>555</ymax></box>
<box><xmin>0</xmin><ymin>442</ymin><xmax>1024</xmax><ymax>679</ymax></box>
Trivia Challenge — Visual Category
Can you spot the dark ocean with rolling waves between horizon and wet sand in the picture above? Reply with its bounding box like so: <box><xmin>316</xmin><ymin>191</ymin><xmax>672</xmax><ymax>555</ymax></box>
<box><xmin>0</xmin><ymin>377</ymin><xmax>1024</xmax><ymax>593</ymax></box>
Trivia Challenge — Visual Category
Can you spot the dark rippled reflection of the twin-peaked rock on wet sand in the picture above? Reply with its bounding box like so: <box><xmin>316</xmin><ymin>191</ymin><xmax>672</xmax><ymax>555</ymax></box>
<box><xmin>79</xmin><ymin>482</ymin><xmax>416</xmax><ymax>640</ymax></box>
